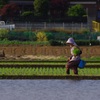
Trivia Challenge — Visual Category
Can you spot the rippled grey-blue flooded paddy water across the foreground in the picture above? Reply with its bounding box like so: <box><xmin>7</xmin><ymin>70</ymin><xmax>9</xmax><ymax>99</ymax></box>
<box><xmin>0</xmin><ymin>80</ymin><xmax>100</xmax><ymax>100</ymax></box>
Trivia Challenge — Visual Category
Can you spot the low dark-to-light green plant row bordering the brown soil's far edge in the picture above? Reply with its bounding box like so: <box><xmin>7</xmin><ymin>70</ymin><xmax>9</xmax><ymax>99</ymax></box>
<box><xmin>0</xmin><ymin>40</ymin><xmax>100</xmax><ymax>46</ymax></box>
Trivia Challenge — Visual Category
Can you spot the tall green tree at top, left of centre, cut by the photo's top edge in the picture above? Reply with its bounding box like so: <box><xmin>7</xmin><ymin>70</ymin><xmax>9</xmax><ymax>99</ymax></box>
<box><xmin>34</xmin><ymin>0</ymin><xmax>49</xmax><ymax>16</ymax></box>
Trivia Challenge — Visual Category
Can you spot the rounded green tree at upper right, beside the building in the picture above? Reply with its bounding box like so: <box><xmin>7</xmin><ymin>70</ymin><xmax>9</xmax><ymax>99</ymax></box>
<box><xmin>67</xmin><ymin>4</ymin><xmax>86</xmax><ymax>17</ymax></box>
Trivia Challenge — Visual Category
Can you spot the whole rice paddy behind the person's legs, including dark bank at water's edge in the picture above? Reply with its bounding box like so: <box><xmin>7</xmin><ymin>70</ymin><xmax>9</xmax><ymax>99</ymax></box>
<box><xmin>0</xmin><ymin>61</ymin><xmax>100</xmax><ymax>79</ymax></box>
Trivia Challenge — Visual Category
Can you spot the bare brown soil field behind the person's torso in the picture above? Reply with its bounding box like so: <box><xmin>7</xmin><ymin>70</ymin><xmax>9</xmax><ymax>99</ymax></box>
<box><xmin>0</xmin><ymin>45</ymin><xmax>100</xmax><ymax>59</ymax></box>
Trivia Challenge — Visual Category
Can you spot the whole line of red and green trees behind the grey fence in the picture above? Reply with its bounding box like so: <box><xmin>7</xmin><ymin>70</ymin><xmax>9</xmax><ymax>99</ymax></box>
<box><xmin>0</xmin><ymin>0</ymin><xmax>86</xmax><ymax>22</ymax></box>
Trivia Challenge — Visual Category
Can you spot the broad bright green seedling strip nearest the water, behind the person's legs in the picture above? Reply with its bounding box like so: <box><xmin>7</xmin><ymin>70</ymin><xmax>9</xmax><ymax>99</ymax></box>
<box><xmin>0</xmin><ymin>67</ymin><xmax>100</xmax><ymax>76</ymax></box>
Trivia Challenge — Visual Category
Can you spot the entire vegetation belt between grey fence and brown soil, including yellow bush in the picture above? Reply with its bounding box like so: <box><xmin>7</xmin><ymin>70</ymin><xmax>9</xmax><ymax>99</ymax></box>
<box><xmin>0</xmin><ymin>29</ymin><xmax>100</xmax><ymax>46</ymax></box>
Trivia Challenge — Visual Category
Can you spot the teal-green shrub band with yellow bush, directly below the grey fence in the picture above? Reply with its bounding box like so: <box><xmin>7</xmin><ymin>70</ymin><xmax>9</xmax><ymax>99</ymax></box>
<box><xmin>0</xmin><ymin>29</ymin><xmax>100</xmax><ymax>41</ymax></box>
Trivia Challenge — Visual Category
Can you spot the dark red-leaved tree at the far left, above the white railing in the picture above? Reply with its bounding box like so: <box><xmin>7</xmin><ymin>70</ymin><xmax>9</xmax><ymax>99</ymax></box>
<box><xmin>0</xmin><ymin>3</ymin><xmax>19</xmax><ymax>20</ymax></box>
